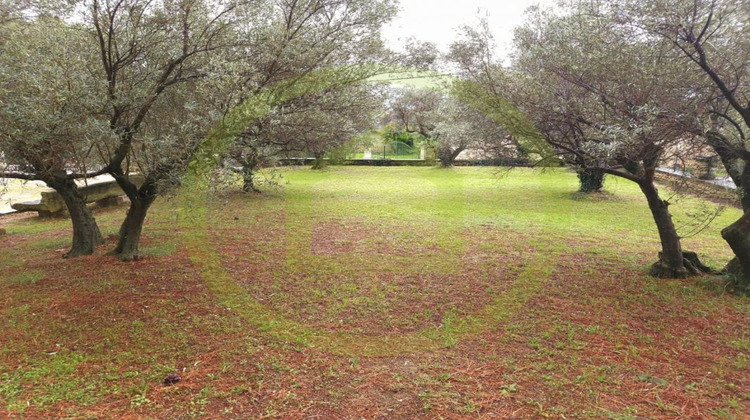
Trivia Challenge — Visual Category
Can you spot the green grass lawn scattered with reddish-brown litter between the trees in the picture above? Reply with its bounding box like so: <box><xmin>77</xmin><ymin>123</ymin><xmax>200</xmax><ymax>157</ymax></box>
<box><xmin>0</xmin><ymin>167</ymin><xmax>750</xmax><ymax>419</ymax></box>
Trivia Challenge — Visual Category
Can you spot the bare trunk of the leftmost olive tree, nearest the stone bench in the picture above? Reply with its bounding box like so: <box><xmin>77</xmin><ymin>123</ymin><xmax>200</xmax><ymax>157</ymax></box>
<box><xmin>46</xmin><ymin>178</ymin><xmax>104</xmax><ymax>258</ymax></box>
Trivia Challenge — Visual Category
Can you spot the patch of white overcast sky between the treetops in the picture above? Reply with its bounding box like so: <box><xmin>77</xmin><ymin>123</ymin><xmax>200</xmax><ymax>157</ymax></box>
<box><xmin>383</xmin><ymin>0</ymin><xmax>555</xmax><ymax>59</ymax></box>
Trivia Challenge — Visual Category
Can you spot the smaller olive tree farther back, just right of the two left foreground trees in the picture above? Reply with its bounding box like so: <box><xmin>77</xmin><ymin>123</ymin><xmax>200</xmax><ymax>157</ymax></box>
<box><xmin>226</xmin><ymin>0</ymin><xmax>396</xmax><ymax>184</ymax></box>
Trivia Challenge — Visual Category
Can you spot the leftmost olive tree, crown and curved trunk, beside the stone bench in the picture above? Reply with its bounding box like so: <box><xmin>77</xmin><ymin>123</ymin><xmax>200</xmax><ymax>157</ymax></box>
<box><xmin>0</xmin><ymin>16</ymin><xmax>113</xmax><ymax>257</ymax></box>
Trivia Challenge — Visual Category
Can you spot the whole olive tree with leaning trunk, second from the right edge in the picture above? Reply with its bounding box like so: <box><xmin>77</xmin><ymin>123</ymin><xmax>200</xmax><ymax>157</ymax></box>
<box><xmin>515</xmin><ymin>2</ymin><xmax>707</xmax><ymax>277</ymax></box>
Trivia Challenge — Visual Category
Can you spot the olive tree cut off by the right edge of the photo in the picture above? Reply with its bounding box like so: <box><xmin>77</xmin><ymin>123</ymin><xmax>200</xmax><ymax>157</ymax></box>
<box><xmin>617</xmin><ymin>0</ymin><xmax>750</xmax><ymax>294</ymax></box>
